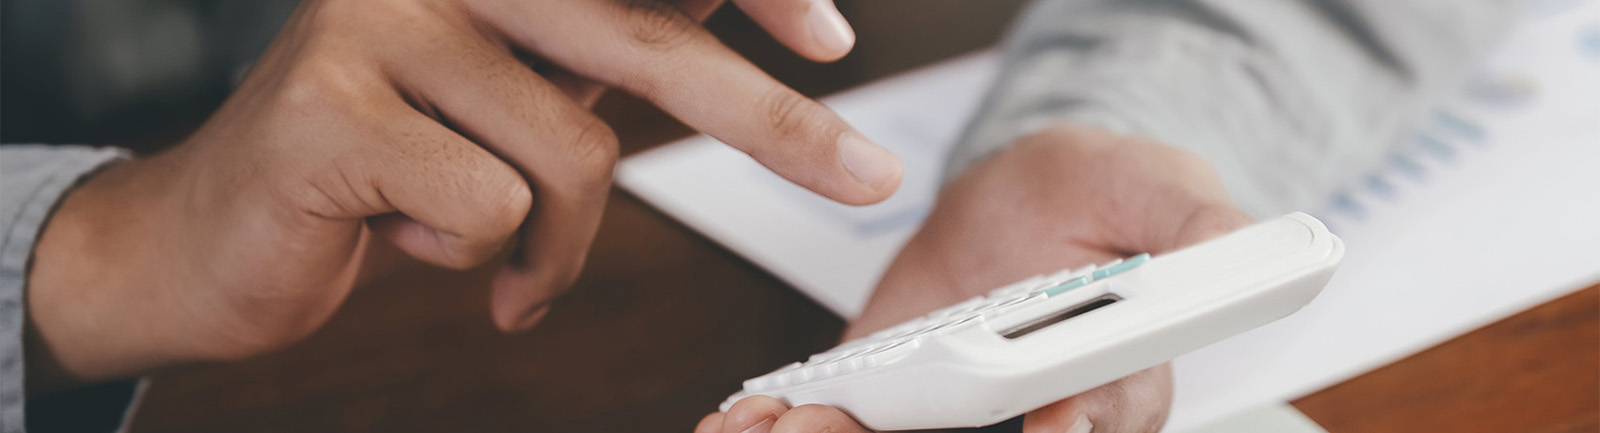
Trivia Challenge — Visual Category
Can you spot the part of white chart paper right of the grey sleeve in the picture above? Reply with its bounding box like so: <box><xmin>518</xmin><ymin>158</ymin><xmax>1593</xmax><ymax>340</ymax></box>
<box><xmin>1170</xmin><ymin>2</ymin><xmax>1600</xmax><ymax>427</ymax></box>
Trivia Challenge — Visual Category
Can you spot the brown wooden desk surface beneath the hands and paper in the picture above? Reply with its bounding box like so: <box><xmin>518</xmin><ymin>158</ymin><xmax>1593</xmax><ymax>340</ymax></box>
<box><xmin>118</xmin><ymin>0</ymin><xmax>1600</xmax><ymax>433</ymax></box>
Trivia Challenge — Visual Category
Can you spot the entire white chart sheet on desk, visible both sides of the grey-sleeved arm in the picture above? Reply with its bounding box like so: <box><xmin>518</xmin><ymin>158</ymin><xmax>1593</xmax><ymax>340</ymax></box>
<box><xmin>618</xmin><ymin>2</ymin><xmax>1600</xmax><ymax>431</ymax></box>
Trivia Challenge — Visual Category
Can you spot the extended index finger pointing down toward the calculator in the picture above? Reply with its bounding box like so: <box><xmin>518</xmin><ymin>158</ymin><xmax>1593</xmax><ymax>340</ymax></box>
<box><xmin>483</xmin><ymin>0</ymin><xmax>901</xmax><ymax>205</ymax></box>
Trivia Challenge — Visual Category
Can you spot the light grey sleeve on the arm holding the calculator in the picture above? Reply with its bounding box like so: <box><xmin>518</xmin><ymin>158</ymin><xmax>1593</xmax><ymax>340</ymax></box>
<box><xmin>947</xmin><ymin>0</ymin><xmax>1514</xmax><ymax>216</ymax></box>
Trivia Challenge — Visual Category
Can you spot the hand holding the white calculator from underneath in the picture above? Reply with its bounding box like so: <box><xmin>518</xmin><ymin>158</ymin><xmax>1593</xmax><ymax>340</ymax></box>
<box><xmin>694</xmin><ymin>126</ymin><xmax>1250</xmax><ymax>433</ymax></box>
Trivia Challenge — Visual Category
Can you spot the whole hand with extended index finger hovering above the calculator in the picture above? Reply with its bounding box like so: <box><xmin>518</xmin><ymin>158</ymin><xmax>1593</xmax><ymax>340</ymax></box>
<box><xmin>27</xmin><ymin>0</ymin><xmax>901</xmax><ymax>390</ymax></box>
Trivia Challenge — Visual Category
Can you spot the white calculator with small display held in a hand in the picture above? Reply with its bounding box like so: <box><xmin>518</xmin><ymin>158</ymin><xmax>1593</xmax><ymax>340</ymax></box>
<box><xmin>722</xmin><ymin>213</ymin><xmax>1344</xmax><ymax>430</ymax></box>
